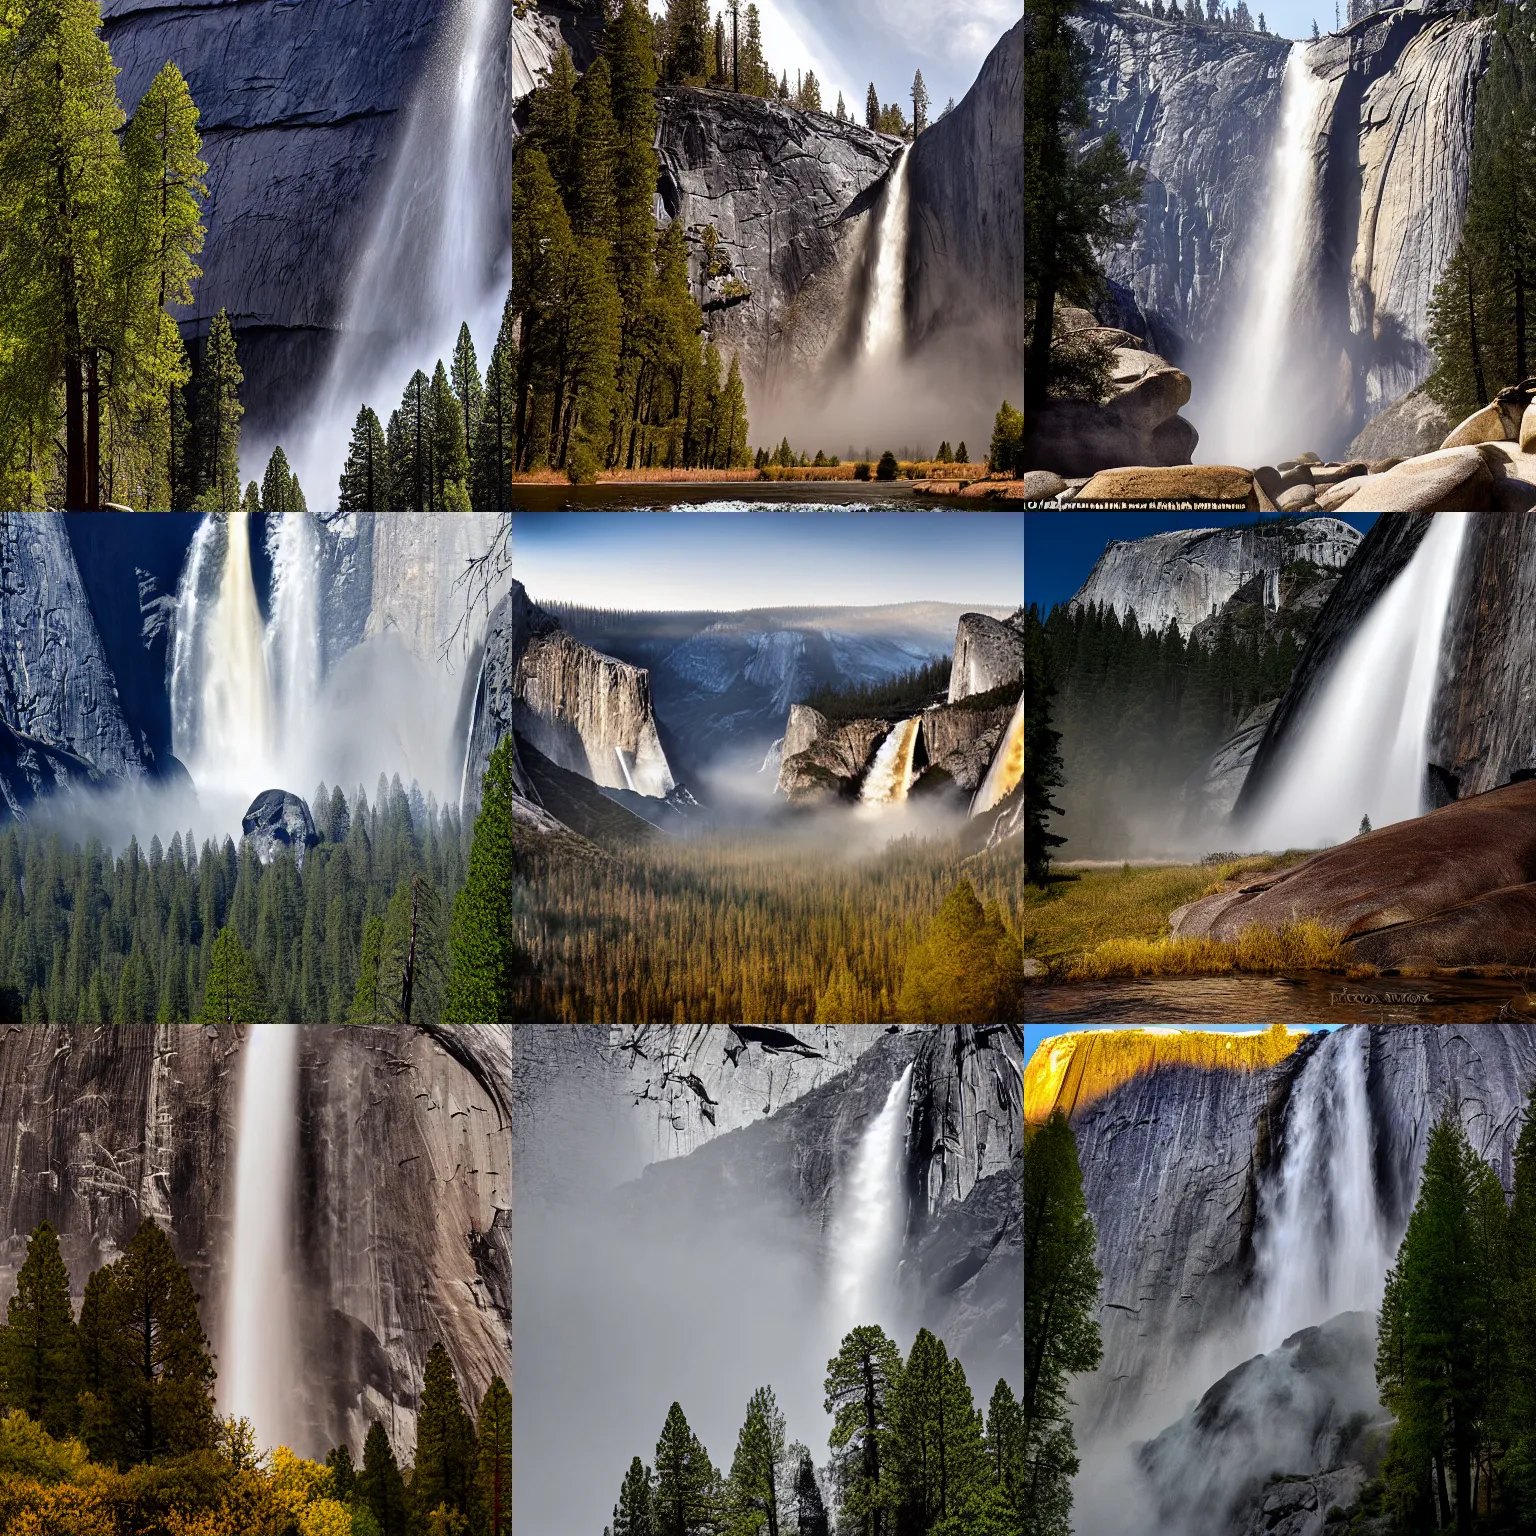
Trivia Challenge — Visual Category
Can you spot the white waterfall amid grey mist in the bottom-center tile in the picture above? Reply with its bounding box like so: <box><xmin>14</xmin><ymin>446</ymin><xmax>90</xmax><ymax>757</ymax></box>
<box><xmin>831</xmin><ymin>1066</ymin><xmax>912</xmax><ymax>1338</ymax></box>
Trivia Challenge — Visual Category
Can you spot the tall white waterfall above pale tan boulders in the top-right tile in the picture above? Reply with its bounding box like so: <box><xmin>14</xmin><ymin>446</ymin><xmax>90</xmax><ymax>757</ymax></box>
<box><xmin>1189</xmin><ymin>43</ymin><xmax>1326</xmax><ymax>464</ymax></box>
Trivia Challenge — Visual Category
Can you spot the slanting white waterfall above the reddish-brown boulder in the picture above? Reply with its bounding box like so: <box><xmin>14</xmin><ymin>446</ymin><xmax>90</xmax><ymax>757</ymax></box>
<box><xmin>1240</xmin><ymin>511</ymin><xmax>1468</xmax><ymax>848</ymax></box>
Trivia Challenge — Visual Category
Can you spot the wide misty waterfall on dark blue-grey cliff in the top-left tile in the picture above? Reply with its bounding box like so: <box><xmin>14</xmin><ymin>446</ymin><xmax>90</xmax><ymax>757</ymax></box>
<box><xmin>292</xmin><ymin>0</ymin><xmax>511</xmax><ymax>505</ymax></box>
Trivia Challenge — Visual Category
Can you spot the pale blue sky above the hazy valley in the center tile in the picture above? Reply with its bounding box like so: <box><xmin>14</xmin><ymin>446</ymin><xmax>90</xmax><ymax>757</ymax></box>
<box><xmin>511</xmin><ymin>511</ymin><xmax>1025</xmax><ymax>610</ymax></box>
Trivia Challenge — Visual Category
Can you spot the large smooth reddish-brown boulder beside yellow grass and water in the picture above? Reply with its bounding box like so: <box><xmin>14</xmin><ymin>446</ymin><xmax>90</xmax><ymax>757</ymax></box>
<box><xmin>1169</xmin><ymin>779</ymin><xmax>1536</xmax><ymax>965</ymax></box>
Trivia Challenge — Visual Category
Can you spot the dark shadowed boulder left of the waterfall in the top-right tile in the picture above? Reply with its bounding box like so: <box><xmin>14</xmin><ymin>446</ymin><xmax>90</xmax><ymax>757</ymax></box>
<box><xmin>1025</xmin><ymin>367</ymin><xmax>1200</xmax><ymax>476</ymax></box>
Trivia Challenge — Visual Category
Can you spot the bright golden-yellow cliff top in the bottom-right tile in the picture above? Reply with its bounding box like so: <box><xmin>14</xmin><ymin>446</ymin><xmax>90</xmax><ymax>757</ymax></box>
<box><xmin>1025</xmin><ymin>1025</ymin><xmax>1306</xmax><ymax>1124</ymax></box>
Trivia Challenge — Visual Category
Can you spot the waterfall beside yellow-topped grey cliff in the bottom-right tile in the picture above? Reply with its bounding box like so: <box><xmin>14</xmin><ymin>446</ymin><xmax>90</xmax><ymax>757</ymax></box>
<box><xmin>1258</xmin><ymin>1028</ymin><xmax>1392</xmax><ymax>1350</ymax></box>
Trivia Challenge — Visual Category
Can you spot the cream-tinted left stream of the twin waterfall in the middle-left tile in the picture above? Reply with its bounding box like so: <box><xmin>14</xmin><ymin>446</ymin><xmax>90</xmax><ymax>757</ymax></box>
<box><xmin>170</xmin><ymin>511</ymin><xmax>273</xmax><ymax>788</ymax></box>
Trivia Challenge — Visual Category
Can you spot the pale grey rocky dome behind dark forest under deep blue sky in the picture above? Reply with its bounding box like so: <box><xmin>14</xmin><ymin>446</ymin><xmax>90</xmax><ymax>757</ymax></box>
<box><xmin>1072</xmin><ymin>518</ymin><xmax>1361</xmax><ymax>634</ymax></box>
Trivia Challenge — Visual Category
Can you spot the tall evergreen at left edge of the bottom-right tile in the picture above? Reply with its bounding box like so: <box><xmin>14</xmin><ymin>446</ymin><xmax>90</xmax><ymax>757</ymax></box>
<box><xmin>1023</xmin><ymin>1111</ymin><xmax>1103</xmax><ymax>1536</ymax></box>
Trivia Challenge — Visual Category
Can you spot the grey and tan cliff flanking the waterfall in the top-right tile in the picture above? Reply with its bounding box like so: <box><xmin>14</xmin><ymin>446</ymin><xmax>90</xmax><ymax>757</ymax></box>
<box><xmin>1078</xmin><ymin>0</ymin><xmax>1490</xmax><ymax>433</ymax></box>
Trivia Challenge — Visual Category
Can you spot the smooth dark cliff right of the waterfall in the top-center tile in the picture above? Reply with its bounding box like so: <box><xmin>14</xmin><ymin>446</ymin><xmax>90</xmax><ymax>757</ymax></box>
<box><xmin>906</xmin><ymin>20</ymin><xmax>1025</xmax><ymax>359</ymax></box>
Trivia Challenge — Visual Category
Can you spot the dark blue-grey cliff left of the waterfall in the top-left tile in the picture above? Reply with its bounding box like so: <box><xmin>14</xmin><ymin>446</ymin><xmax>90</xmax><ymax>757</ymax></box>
<box><xmin>101</xmin><ymin>0</ymin><xmax>507</xmax><ymax>445</ymax></box>
